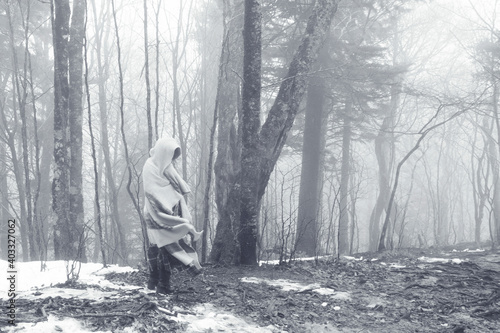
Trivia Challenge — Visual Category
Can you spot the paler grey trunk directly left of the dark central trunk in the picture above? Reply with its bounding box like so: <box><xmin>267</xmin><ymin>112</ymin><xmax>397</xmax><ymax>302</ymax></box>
<box><xmin>210</xmin><ymin>0</ymin><xmax>243</xmax><ymax>264</ymax></box>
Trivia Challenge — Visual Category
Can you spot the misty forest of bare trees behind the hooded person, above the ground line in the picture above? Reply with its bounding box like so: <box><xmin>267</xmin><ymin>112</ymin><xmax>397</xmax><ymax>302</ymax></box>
<box><xmin>0</xmin><ymin>0</ymin><xmax>500</xmax><ymax>265</ymax></box>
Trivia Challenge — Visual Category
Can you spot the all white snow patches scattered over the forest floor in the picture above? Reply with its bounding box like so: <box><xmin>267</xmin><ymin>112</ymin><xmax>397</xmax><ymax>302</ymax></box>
<box><xmin>0</xmin><ymin>249</ymin><xmax>476</xmax><ymax>333</ymax></box>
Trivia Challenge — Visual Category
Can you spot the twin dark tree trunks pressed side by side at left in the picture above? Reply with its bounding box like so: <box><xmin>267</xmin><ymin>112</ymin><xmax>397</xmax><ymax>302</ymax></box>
<box><xmin>52</xmin><ymin>0</ymin><xmax>86</xmax><ymax>260</ymax></box>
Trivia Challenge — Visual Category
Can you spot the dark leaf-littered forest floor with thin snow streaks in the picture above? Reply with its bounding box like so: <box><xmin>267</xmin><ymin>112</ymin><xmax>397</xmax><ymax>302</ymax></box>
<box><xmin>3</xmin><ymin>245</ymin><xmax>500</xmax><ymax>333</ymax></box>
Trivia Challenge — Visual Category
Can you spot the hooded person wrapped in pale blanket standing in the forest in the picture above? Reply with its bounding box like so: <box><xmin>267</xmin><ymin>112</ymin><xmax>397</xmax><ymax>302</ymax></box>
<box><xmin>142</xmin><ymin>138</ymin><xmax>202</xmax><ymax>294</ymax></box>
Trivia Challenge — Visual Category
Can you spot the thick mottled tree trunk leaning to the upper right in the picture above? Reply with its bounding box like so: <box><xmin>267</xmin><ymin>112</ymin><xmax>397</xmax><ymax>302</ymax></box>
<box><xmin>241</xmin><ymin>0</ymin><xmax>338</xmax><ymax>264</ymax></box>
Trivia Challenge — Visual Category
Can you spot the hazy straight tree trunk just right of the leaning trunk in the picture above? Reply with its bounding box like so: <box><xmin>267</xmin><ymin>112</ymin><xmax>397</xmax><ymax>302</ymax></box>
<box><xmin>295</xmin><ymin>76</ymin><xmax>326</xmax><ymax>256</ymax></box>
